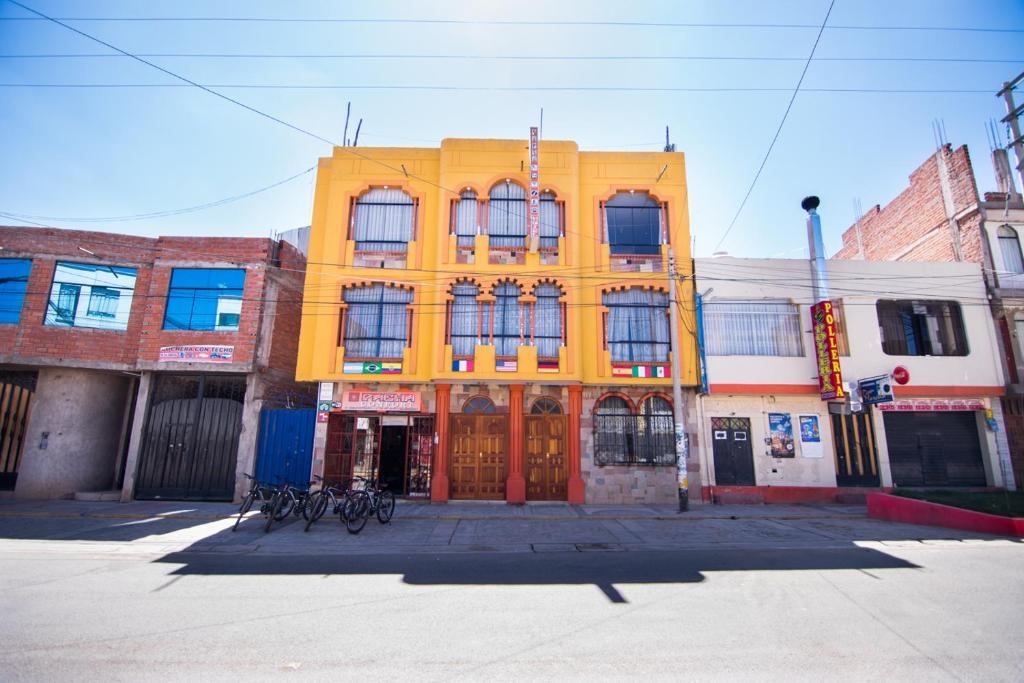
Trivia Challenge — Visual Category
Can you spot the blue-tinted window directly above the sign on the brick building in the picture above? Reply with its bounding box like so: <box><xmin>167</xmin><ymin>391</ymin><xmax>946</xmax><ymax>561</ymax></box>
<box><xmin>164</xmin><ymin>268</ymin><xmax>246</xmax><ymax>332</ymax></box>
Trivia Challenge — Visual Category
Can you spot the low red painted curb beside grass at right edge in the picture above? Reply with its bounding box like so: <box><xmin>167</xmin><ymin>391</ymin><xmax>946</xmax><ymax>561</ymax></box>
<box><xmin>867</xmin><ymin>494</ymin><xmax>1024</xmax><ymax>537</ymax></box>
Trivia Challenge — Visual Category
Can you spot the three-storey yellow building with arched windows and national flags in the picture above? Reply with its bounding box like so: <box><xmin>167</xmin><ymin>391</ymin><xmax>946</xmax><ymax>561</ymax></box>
<box><xmin>297</xmin><ymin>139</ymin><xmax>697</xmax><ymax>503</ymax></box>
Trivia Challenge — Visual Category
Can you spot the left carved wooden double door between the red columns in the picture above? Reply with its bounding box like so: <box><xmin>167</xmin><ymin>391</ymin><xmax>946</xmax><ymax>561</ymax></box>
<box><xmin>451</xmin><ymin>414</ymin><xmax>508</xmax><ymax>501</ymax></box>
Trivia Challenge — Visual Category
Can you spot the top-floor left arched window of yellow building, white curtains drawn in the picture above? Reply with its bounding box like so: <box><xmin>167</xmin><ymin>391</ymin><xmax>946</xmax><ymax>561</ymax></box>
<box><xmin>351</xmin><ymin>187</ymin><xmax>416</xmax><ymax>252</ymax></box>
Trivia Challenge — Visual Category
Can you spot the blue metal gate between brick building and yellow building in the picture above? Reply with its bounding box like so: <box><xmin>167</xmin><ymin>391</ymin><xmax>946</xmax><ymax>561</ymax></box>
<box><xmin>256</xmin><ymin>409</ymin><xmax>316</xmax><ymax>485</ymax></box>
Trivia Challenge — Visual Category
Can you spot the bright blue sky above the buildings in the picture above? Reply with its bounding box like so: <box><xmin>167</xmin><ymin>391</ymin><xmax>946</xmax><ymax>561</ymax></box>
<box><xmin>0</xmin><ymin>0</ymin><xmax>1024</xmax><ymax>257</ymax></box>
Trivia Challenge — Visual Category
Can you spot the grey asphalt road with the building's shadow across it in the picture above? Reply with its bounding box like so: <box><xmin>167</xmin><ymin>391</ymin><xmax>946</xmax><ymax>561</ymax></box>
<box><xmin>0</xmin><ymin>507</ymin><xmax>1024</xmax><ymax>681</ymax></box>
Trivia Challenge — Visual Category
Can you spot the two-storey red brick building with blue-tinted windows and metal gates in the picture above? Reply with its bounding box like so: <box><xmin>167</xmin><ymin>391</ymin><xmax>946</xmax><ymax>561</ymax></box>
<box><xmin>0</xmin><ymin>227</ymin><xmax>305</xmax><ymax>500</ymax></box>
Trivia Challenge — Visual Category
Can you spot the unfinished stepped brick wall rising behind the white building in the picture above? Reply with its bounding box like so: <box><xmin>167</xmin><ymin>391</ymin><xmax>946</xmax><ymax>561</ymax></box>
<box><xmin>833</xmin><ymin>144</ymin><xmax>982</xmax><ymax>263</ymax></box>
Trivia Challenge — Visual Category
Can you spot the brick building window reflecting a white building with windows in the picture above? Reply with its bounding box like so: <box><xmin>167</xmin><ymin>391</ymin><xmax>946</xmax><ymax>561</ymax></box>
<box><xmin>43</xmin><ymin>261</ymin><xmax>135</xmax><ymax>330</ymax></box>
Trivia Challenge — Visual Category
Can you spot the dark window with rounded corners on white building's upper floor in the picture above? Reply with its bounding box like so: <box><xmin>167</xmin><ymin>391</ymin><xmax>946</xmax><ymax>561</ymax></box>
<box><xmin>874</xmin><ymin>300</ymin><xmax>968</xmax><ymax>355</ymax></box>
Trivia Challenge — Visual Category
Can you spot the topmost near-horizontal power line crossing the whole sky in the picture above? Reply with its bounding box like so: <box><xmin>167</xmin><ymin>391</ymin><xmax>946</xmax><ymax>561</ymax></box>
<box><xmin>0</xmin><ymin>15</ymin><xmax>1024</xmax><ymax>34</ymax></box>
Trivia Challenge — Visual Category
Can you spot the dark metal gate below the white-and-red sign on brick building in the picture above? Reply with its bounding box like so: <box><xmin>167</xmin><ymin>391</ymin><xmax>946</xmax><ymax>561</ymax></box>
<box><xmin>135</xmin><ymin>375</ymin><xmax>246</xmax><ymax>501</ymax></box>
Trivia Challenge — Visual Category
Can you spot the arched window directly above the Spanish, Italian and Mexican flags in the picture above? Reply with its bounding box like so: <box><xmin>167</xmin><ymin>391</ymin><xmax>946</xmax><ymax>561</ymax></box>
<box><xmin>602</xmin><ymin>287</ymin><xmax>670</xmax><ymax>362</ymax></box>
